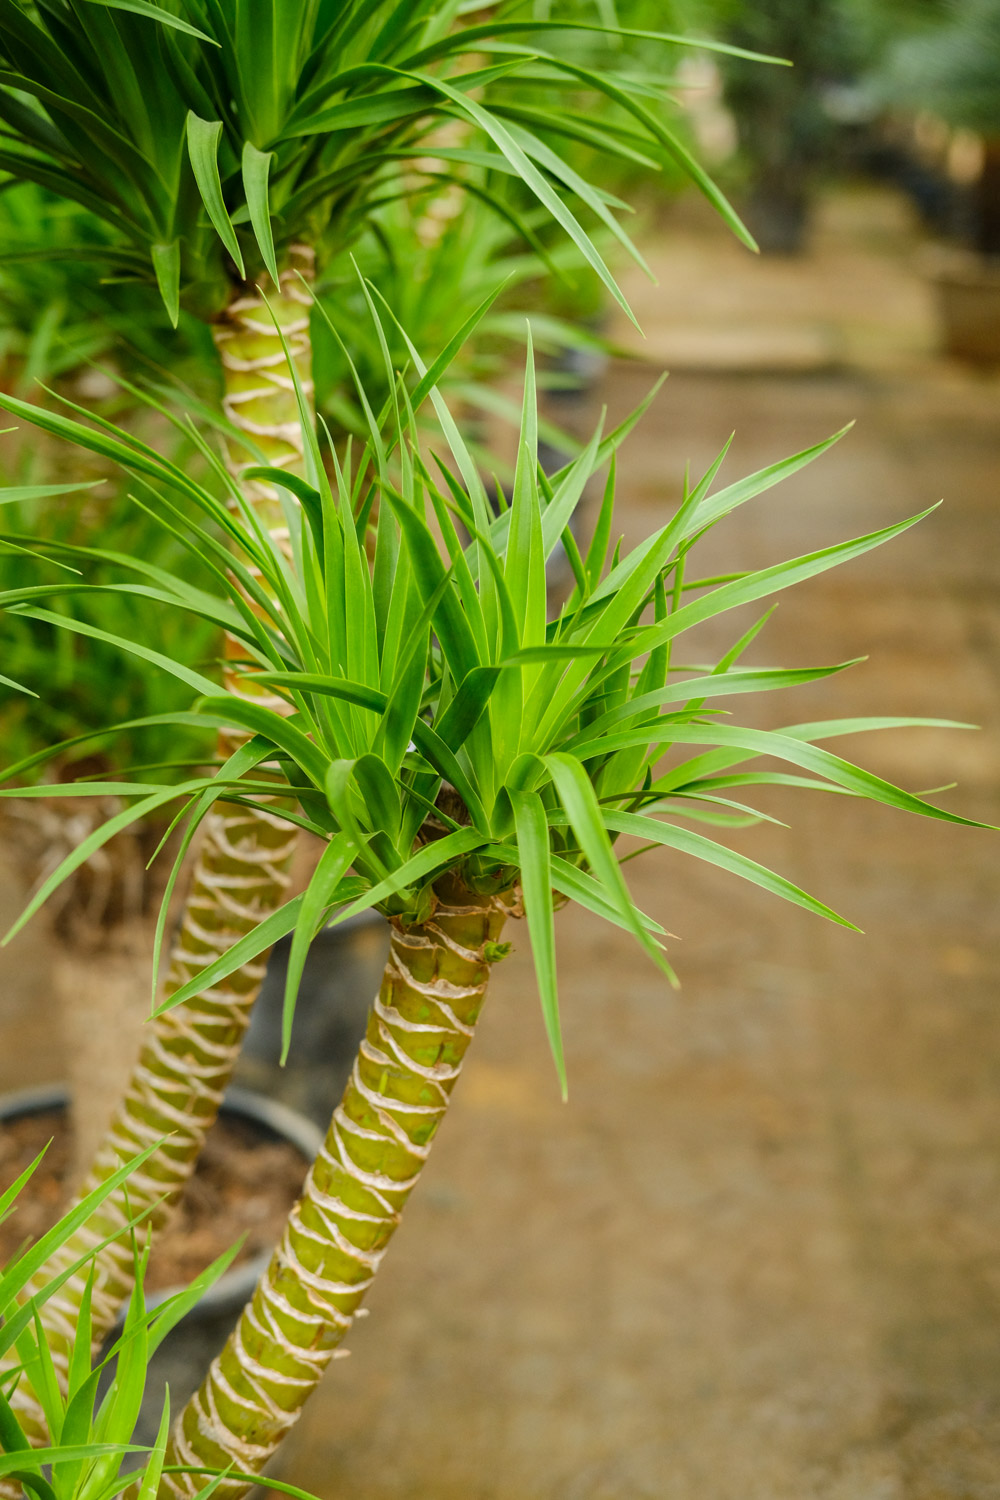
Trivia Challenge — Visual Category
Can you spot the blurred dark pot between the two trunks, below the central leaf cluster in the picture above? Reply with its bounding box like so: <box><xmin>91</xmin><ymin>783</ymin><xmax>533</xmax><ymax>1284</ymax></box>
<box><xmin>235</xmin><ymin>912</ymin><xmax>388</xmax><ymax>1131</ymax></box>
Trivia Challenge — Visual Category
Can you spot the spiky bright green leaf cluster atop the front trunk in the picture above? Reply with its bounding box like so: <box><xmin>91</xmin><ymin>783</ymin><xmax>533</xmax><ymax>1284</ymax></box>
<box><xmin>0</xmin><ymin>293</ymin><xmax>983</xmax><ymax>1092</ymax></box>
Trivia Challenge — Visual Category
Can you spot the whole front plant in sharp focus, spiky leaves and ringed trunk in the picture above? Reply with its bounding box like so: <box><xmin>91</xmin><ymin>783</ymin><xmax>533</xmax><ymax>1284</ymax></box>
<box><xmin>0</xmin><ymin>316</ymin><xmax>989</xmax><ymax>1496</ymax></box>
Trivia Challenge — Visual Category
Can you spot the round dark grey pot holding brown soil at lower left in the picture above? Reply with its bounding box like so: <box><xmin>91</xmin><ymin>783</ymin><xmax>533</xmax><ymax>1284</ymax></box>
<box><xmin>0</xmin><ymin>1085</ymin><xmax>322</xmax><ymax>1443</ymax></box>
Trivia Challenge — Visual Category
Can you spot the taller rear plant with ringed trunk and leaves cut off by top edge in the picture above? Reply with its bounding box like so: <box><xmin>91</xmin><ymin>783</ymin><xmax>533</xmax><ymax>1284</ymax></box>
<box><xmin>0</xmin><ymin>0</ymin><xmax>773</xmax><ymax>1404</ymax></box>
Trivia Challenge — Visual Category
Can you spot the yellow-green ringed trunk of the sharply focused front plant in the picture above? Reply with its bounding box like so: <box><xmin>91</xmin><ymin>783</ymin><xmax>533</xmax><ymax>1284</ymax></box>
<box><xmin>160</xmin><ymin>876</ymin><xmax>516</xmax><ymax>1500</ymax></box>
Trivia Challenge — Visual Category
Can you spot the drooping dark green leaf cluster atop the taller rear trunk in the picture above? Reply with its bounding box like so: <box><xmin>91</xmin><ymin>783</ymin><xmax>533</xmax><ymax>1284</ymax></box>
<box><xmin>0</xmin><ymin>0</ymin><xmax>773</xmax><ymax>321</ymax></box>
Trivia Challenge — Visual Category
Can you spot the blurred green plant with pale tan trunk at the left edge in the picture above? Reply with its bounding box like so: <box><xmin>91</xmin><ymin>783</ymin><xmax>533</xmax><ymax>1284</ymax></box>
<box><xmin>0</xmin><ymin>450</ymin><xmax>222</xmax><ymax>1172</ymax></box>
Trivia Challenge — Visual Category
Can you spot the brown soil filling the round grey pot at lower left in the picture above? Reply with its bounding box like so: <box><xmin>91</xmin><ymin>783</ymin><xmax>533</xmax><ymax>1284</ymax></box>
<box><xmin>0</xmin><ymin>1110</ymin><xmax>307</xmax><ymax>1292</ymax></box>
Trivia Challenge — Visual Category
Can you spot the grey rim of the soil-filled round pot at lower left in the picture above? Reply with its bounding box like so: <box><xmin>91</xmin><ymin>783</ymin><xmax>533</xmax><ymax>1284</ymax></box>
<box><xmin>0</xmin><ymin>1083</ymin><xmax>322</xmax><ymax>1317</ymax></box>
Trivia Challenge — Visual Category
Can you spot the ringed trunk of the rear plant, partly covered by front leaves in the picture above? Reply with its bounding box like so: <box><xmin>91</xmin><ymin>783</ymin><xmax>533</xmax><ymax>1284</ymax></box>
<box><xmin>0</xmin><ymin>248</ymin><xmax>313</xmax><ymax>1446</ymax></box>
